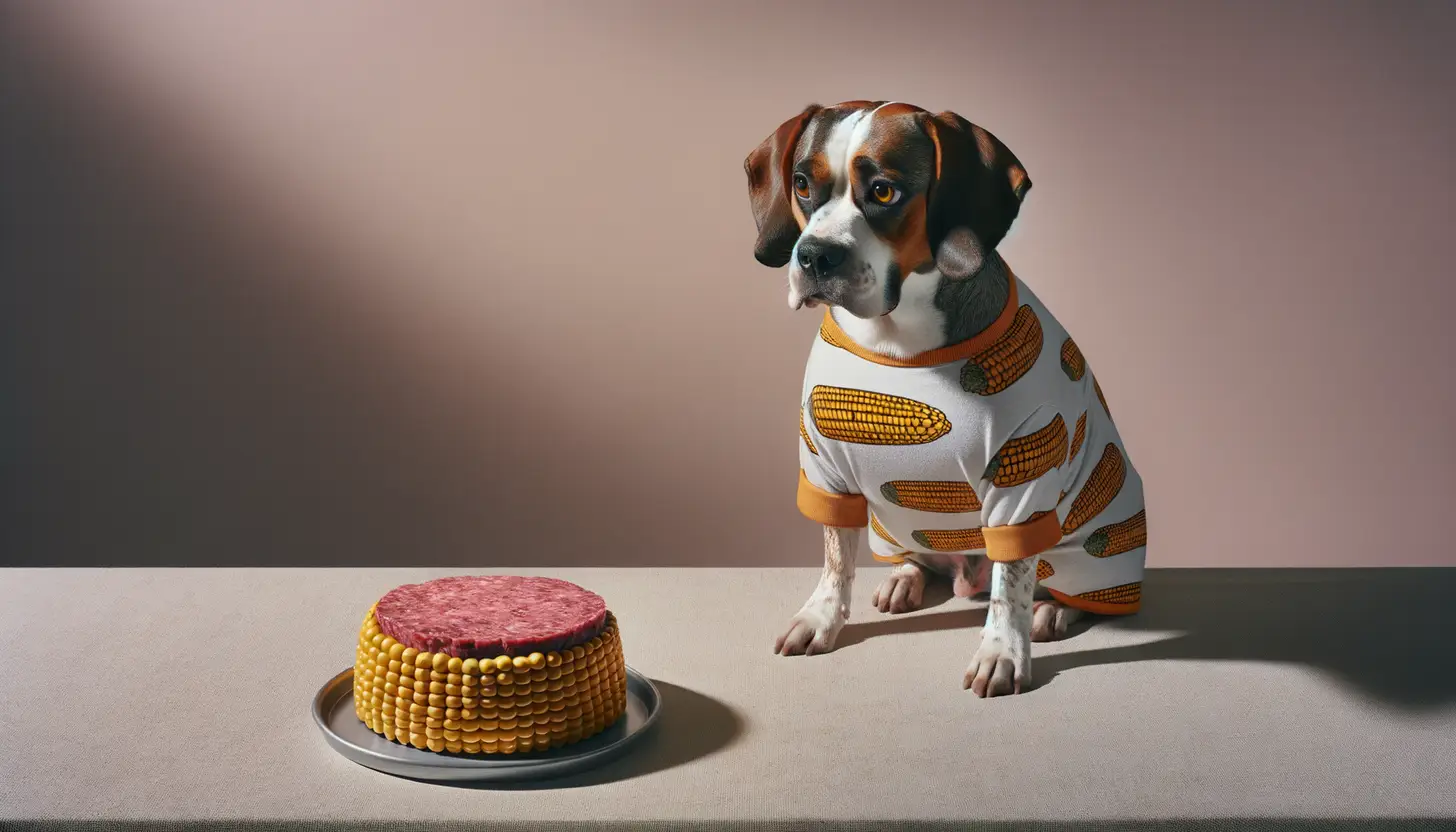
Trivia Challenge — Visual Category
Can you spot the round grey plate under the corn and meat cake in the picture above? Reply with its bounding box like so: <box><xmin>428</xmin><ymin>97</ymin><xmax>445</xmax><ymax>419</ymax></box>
<box><xmin>313</xmin><ymin>666</ymin><xmax>662</xmax><ymax>782</ymax></box>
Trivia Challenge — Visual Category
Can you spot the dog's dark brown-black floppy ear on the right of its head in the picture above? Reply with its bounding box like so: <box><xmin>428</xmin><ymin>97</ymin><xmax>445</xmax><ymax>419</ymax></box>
<box><xmin>922</xmin><ymin>112</ymin><xmax>1031</xmax><ymax>280</ymax></box>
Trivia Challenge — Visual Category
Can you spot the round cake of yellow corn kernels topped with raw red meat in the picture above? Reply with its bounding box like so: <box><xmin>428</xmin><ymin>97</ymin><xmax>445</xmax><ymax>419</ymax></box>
<box><xmin>354</xmin><ymin>576</ymin><xmax>626</xmax><ymax>755</ymax></box>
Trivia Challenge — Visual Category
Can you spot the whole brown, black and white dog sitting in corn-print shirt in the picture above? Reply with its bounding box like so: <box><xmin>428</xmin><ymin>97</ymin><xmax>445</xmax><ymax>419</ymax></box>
<box><xmin>744</xmin><ymin>101</ymin><xmax>1147</xmax><ymax>696</ymax></box>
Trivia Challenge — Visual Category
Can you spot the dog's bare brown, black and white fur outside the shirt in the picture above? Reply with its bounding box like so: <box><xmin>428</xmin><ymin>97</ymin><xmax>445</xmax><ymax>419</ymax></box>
<box><xmin>744</xmin><ymin>101</ymin><xmax>1080</xmax><ymax>696</ymax></box>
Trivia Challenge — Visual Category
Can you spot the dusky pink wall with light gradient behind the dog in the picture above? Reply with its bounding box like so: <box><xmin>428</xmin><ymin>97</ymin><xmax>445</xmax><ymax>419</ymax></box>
<box><xmin>0</xmin><ymin>0</ymin><xmax>1456</xmax><ymax>567</ymax></box>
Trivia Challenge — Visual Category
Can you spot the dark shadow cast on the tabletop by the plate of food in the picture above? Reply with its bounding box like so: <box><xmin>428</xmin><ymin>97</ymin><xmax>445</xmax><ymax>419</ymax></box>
<box><xmin>419</xmin><ymin>679</ymin><xmax>743</xmax><ymax>791</ymax></box>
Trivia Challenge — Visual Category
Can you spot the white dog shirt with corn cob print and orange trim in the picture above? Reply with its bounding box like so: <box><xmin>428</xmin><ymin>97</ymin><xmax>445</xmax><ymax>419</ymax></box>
<box><xmin>798</xmin><ymin>269</ymin><xmax>1147</xmax><ymax>615</ymax></box>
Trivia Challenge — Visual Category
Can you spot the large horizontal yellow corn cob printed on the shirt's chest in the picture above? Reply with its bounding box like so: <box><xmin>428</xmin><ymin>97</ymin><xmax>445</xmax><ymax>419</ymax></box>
<box><xmin>810</xmin><ymin>386</ymin><xmax>951</xmax><ymax>444</ymax></box>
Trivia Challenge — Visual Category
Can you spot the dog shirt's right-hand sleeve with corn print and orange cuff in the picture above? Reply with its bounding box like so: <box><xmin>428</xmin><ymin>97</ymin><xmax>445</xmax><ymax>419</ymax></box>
<box><xmin>978</xmin><ymin>405</ymin><xmax>1069</xmax><ymax>562</ymax></box>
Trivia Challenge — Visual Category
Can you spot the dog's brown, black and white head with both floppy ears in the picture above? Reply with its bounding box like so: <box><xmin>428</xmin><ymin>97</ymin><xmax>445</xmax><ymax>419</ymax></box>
<box><xmin>744</xmin><ymin>101</ymin><xmax>1031</xmax><ymax>318</ymax></box>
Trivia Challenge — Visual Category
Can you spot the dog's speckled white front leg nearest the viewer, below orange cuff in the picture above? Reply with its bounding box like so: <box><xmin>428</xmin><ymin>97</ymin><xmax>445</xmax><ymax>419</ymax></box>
<box><xmin>964</xmin><ymin>557</ymin><xmax>1041</xmax><ymax>696</ymax></box>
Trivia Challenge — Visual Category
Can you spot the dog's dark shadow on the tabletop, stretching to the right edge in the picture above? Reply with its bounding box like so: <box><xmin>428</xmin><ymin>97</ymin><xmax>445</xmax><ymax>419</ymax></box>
<box><xmin>840</xmin><ymin>568</ymin><xmax>1456</xmax><ymax>711</ymax></box>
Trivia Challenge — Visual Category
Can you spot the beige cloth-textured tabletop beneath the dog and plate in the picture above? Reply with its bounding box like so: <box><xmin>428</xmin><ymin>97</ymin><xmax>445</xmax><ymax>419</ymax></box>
<box><xmin>0</xmin><ymin>567</ymin><xmax>1456</xmax><ymax>831</ymax></box>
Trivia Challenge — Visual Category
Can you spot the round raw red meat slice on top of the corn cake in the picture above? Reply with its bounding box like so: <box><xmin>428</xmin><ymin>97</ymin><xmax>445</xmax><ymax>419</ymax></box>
<box><xmin>374</xmin><ymin>576</ymin><xmax>607</xmax><ymax>659</ymax></box>
